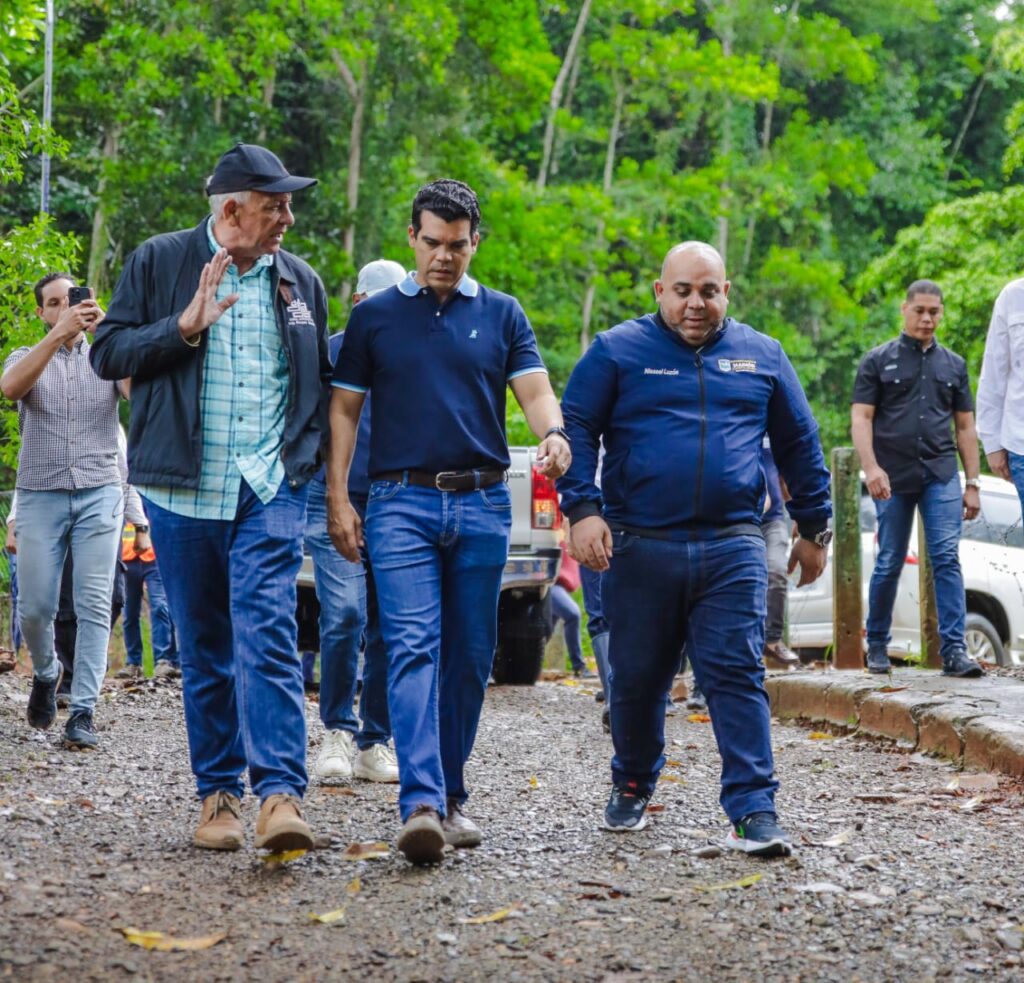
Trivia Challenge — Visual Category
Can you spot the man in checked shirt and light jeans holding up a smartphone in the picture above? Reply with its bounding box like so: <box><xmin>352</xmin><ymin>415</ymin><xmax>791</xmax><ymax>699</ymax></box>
<box><xmin>0</xmin><ymin>273</ymin><xmax>124</xmax><ymax>751</ymax></box>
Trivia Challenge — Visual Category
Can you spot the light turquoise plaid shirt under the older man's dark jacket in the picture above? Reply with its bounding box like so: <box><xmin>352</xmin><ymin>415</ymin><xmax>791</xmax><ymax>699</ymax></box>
<box><xmin>139</xmin><ymin>220</ymin><xmax>288</xmax><ymax>521</ymax></box>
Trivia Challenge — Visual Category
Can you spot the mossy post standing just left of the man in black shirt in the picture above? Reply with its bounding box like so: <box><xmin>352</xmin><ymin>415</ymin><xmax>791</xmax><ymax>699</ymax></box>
<box><xmin>831</xmin><ymin>447</ymin><xmax>864</xmax><ymax>669</ymax></box>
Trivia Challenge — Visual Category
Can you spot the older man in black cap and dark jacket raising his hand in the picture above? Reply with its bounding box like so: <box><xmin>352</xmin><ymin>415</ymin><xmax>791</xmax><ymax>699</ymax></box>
<box><xmin>92</xmin><ymin>143</ymin><xmax>331</xmax><ymax>851</ymax></box>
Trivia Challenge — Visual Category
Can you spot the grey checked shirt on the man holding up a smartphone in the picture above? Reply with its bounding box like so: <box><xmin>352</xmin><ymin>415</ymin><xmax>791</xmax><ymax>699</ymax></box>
<box><xmin>4</xmin><ymin>339</ymin><xmax>121</xmax><ymax>492</ymax></box>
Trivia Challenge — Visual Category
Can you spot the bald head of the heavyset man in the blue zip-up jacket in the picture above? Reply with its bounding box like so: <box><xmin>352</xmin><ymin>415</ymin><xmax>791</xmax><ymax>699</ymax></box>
<box><xmin>654</xmin><ymin>242</ymin><xmax>729</xmax><ymax>348</ymax></box>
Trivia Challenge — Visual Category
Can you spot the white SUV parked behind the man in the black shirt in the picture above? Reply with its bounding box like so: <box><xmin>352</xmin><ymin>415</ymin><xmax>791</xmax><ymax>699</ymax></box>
<box><xmin>788</xmin><ymin>474</ymin><xmax>1024</xmax><ymax>666</ymax></box>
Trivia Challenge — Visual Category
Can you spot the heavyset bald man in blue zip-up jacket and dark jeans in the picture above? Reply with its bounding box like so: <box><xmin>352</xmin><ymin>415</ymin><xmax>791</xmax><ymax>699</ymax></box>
<box><xmin>558</xmin><ymin>243</ymin><xmax>831</xmax><ymax>856</ymax></box>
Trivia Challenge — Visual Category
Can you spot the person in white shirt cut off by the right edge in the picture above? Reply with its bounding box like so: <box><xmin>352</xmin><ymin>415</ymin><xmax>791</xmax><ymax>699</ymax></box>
<box><xmin>977</xmin><ymin>279</ymin><xmax>1024</xmax><ymax>503</ymax></box>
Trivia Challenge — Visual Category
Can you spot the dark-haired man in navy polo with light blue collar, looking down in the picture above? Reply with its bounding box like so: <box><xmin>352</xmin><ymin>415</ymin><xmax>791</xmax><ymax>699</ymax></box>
<box><xmin>328</xmin><ymin>180</ymin><xmax>571</xmax><ymax>863</ymax></box>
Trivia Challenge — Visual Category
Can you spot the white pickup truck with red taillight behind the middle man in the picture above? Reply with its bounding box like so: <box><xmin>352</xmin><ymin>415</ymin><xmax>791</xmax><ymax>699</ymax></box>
<box><xmin>297</xmin><ymin>447</ymin><xmax>562</xmax><ymax>686</ymax></box>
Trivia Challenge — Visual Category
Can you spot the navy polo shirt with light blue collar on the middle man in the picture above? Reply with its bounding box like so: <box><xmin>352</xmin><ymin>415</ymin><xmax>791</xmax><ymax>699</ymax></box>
<box><xmin>332</xmin><ymin>273</ymin><xmax>547</xmax><ymax>476</ymax></box>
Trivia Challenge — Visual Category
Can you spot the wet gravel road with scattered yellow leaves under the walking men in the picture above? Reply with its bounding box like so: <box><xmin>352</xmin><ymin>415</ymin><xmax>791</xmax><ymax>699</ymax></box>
<box><xmin>0</xmin><ymin>675</ymin><xmax>1024</xmax><ymax>983</ymax></box>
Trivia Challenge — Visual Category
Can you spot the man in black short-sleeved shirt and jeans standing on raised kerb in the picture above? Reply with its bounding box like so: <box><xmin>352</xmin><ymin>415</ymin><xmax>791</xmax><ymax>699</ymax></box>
<box><xmin>851</xmin><ymin>280</ymin><xmax>984</xmax><ymax>676</ymax></box>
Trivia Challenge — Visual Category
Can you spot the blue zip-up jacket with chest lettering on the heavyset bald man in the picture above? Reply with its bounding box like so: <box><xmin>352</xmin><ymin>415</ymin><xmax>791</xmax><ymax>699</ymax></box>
<box><xmin>558</xmin><ymin>314</ymin><xmax>831</xmax><ymax>539</ymax></box>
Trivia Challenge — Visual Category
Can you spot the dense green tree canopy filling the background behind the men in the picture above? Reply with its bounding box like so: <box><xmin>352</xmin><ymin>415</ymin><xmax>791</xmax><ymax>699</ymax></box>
<box><xmin>0</xmin><ymin>0</ymin><xmax>1024</xmax><ymax>465</ymax></box>
